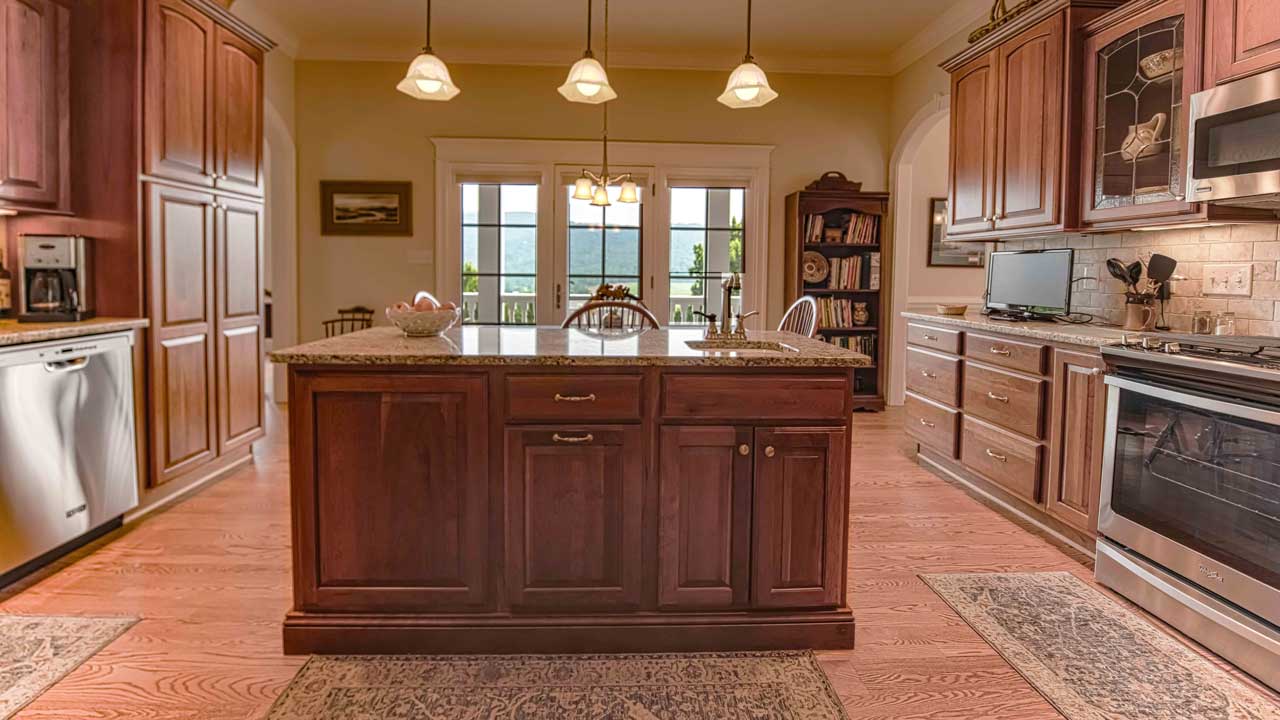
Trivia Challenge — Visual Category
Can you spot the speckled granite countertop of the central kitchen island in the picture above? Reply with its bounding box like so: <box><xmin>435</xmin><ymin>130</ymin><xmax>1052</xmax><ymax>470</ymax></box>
<box><xmin>271</xmin><ymin>325</ymin><xmax>872</xmax><ymax>368</ymax></box>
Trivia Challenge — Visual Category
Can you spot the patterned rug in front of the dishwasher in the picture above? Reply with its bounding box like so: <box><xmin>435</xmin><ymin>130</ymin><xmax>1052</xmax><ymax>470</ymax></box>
<box><xmin>0</xmin><ymin>614</ymin><xmax>138</xmax><ymax>720</ymax></box>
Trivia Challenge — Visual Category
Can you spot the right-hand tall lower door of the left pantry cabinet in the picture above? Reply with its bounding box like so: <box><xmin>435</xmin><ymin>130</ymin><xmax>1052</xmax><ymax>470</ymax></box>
<box><xmin>215</xmin><ymin>199</ymin><xmax>265</xmax><ymax>452</ymax></box>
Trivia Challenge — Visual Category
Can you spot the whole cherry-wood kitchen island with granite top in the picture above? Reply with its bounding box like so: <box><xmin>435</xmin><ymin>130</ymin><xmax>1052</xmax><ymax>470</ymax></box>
<box><xmin>271</xmin><ymin>327</ymin><xmax>870</xmax><ymax>653</ymax></box>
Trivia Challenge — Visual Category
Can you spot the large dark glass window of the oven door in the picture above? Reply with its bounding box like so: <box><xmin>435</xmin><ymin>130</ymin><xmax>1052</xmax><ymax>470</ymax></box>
<box><xmin>1111</xmin><ymin>389</ymin><xmax>1280</xmax><ymax>587</ymax></box>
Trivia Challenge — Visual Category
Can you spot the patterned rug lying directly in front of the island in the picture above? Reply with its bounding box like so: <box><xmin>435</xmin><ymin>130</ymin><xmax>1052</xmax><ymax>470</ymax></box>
<box><xmin>268</xmin><ymin>651</ymin><xmax>846</xmax><ymax>720</ymax></box>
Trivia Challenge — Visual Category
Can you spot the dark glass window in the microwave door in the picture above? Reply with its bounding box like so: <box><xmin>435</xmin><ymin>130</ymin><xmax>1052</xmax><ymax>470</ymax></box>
<box><xmin>1193</xmin><ymin>100</ymin><xmax>1280</xmax><ymax>179</ymax></box>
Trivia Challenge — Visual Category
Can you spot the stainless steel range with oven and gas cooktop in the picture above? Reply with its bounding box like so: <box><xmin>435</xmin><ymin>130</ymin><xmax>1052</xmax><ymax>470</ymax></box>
<box><xmin>1094</xmin><ymin>334</ymin><xmax>1280</xmax><ymax>689</ymax></box>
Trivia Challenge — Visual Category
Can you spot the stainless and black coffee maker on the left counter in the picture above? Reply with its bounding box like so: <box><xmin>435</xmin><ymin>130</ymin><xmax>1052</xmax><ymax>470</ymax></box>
<box><xmin>18</xmin><ymin>234</ymin><xmax>93</xmax><ymax>323</ymax></box>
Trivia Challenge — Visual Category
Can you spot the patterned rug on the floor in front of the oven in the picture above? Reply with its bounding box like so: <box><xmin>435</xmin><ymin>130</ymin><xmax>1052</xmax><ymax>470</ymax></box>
<box><xmin>920</xmin><ymin>573</ymin><xmax>1280</xmax><ymax>720</ymax></box>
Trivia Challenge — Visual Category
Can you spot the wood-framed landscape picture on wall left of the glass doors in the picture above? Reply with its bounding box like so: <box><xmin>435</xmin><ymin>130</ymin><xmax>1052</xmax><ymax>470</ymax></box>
<box><xmin>320</xmin><ymin>181</ymin><xmax>413</xmax><ymax>236</ymax></box>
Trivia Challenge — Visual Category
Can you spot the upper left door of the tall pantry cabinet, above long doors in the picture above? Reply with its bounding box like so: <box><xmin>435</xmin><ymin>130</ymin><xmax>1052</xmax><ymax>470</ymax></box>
<box><xmin>142</xmin><ymin>0</ymin><xmax>216</xmax><ymax>186</ymax></box>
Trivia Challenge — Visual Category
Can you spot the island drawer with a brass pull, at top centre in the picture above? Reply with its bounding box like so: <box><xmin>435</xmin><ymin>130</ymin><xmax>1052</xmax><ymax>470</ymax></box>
<box><xmin>506</xmin><ymin>375</ymin><xmax>640</xmax><ymax>421</ymax></box>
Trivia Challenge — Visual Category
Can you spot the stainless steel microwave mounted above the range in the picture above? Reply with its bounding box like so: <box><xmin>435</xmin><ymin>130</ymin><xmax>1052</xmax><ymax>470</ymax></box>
<box><xmin>1187</xmin><ymin>69</ymin><xmax>1280</xmax><ymax>210</ymax></box>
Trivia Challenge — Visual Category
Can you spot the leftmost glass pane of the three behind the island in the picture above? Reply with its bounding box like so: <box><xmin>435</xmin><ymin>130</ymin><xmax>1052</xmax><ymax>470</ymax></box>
<box><xmin>461</xmin><ymin>183</ymin><xmax>538</xmax><ymax>325</ymax></box>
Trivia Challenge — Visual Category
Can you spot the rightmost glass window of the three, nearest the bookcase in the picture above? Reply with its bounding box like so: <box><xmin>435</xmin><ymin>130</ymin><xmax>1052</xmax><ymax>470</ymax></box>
<box><xmin>667</xmin><ymin>187</ymin><xmax>746</xmax><ymax>324</ymax></box>
